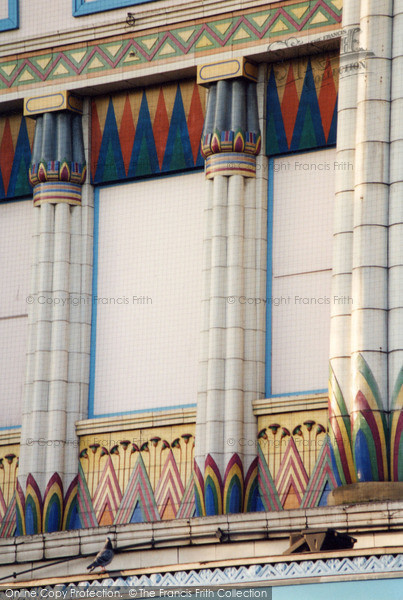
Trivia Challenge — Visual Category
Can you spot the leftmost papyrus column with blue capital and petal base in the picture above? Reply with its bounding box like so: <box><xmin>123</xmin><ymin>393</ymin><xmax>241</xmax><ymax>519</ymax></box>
<box><xmin>17</xmin><ymin>92</ymin><xmax>91</xmax><ymax>534</ymax></box>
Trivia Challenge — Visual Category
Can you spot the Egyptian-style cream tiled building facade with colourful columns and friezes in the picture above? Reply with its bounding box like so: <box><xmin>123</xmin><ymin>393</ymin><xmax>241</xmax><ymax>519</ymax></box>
<box><xmin>0</xmin><ymin>0</ymin><xmax>403</xmax><ymax>592</ymax></box>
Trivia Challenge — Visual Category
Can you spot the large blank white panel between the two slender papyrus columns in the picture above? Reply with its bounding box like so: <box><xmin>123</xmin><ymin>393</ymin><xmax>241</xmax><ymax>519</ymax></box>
<box><xmin>94</xmin><ymin>173</ymin><xmax>204</xmax><ymax>415</ymax></box>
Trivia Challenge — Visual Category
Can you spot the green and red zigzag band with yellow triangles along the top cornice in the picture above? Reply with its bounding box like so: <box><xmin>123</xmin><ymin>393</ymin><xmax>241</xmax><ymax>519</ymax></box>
<box><xmin>0</xmin><ymin>0</ymin><xmax>342</xmax><ymax>90</ymax></box>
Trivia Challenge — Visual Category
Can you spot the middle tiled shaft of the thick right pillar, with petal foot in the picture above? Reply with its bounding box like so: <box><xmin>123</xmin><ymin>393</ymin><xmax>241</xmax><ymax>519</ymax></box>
<box><xmin>351</xmin><ymin>0</ymin><xmax>393</xmax><ymax>482</ymax></box>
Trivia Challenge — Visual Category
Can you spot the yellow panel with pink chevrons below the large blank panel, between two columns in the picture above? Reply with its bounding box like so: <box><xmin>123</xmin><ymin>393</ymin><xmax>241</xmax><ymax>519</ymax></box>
<box><xmin>78</xmin><ymin>424</ymin><xmax>195</xmax><ymax>527</ymax></box>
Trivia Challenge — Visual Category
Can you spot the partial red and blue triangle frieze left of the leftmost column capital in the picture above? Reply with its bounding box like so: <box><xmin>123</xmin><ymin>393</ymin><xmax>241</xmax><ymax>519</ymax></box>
<box><xmin>0</xmin><ymin>115</ymin><xmax>35</xmax><ymax>200</ymax></box>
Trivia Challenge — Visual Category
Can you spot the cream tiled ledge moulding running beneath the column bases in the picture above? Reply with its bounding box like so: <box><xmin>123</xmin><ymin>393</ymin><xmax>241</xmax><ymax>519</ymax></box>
<box><xmin>0</xmin><ymin>501</ymin><xmax>403</xmax><ymax>579</ymax></box>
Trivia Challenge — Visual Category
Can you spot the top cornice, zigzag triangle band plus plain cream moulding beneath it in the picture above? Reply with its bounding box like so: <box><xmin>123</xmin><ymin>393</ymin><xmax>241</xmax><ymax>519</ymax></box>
<box><xmin>0</xmin><ymin>0</ymin><xmax>341</xmax><ymax>102</ymax></box>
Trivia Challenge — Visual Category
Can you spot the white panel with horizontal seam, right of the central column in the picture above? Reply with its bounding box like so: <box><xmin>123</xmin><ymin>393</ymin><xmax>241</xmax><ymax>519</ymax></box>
<box><xmin>267</xmin><ymin>148</ymin><xmax>339</xmax><ymax>395</ymax></box>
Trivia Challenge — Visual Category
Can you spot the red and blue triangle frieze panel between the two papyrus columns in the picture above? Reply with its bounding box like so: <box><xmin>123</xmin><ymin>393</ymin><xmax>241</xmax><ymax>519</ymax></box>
<box><xmin>91</xmin><ymin>80</ymin><xmax>205</xmax><ymax>183</ymax></box>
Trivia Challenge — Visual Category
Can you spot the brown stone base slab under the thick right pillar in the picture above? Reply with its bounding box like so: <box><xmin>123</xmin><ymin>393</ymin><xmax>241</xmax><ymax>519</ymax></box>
<box><xmin>327</xmin><ymin>481</ymin><xmax>403</xmax><ymax>506</ymax></box>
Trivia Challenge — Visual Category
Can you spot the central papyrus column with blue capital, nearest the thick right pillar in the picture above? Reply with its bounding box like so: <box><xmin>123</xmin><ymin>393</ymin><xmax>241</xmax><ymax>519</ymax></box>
<box><xmin>195</xmin><ymin>60</ymin><xmax>266</xmax><ymax>514</ymax></box>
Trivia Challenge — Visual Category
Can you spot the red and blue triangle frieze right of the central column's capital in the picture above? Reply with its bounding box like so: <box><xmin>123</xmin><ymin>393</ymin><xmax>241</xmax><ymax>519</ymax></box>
<box><xmin>266</xmin><ymin>54</ymin><xmax>339</xmax><ymax>155</ymax></box>
